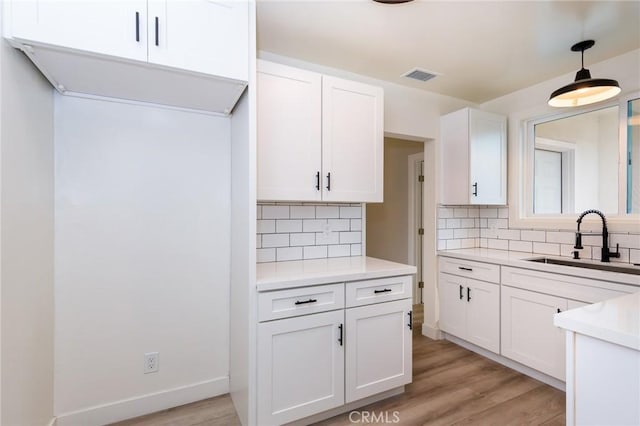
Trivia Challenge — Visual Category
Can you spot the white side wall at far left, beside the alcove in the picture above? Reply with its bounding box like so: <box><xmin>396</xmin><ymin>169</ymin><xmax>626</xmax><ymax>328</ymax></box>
<box><xmin>0</xmin><ymin>35</ymin><xmax>53</xmax><ymax>426</ymax></box>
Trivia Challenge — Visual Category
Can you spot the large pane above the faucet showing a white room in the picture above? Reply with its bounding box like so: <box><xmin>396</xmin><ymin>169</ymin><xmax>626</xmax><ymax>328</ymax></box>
<box><xmin>533</xmin><ymin>106</ymin><xmax>616</xmax><ymax>215</ymax></box>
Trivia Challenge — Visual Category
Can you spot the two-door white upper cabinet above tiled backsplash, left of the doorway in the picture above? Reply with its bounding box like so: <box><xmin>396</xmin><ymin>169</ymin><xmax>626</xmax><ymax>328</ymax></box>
<box><xmin>258</xmin><ymin>61</ymin><xmax>384</xmax><ymax>202</ymax></box>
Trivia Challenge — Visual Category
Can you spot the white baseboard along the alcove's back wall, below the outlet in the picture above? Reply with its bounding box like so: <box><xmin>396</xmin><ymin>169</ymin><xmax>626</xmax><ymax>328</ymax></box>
<box><xmin>55</xmin><ymin>376</ymin><xmax>229</xmax><ymax>426</ymax></box>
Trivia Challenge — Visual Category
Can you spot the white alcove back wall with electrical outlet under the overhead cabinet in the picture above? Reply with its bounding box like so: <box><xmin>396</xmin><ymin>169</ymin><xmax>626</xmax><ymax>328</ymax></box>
<box><xmin>55</xmin><ymin>95</ymin><xmax>230</xmax><ymax>425</ymax></box>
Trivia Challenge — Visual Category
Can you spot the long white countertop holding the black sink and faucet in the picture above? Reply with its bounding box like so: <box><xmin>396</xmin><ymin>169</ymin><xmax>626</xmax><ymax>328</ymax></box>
<box><xmin>438</xmin><ymin>248</ymin><xmax>640</xmax><ymax>287</ymax></box>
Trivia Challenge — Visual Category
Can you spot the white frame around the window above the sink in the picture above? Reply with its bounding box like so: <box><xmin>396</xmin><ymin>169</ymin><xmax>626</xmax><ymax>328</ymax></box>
<box><xmin>509</xmin><ymin>91</ymin><xmax>640</xmax><ymax>233</ymax></box>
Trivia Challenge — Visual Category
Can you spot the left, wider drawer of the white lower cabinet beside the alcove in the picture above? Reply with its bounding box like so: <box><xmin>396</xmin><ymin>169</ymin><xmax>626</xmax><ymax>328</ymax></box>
<box><xmin>258</xmin><ymin>283</ymin><xmax>344</xmax><ymax>322</ymax></box>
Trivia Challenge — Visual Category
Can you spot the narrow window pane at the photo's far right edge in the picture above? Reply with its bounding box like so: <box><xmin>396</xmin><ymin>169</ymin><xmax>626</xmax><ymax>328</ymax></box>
<box><xmin>627</xmin><ymin>99</ymin><xmax>640</xmax><ymax>213</ymax></box>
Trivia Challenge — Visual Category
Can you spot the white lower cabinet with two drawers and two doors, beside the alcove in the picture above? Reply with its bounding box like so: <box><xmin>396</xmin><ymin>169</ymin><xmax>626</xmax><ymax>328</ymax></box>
<box><xmin>257</xmin><ymin>276</ymin><xmax>413</xmax><ymax>426</ymax></box>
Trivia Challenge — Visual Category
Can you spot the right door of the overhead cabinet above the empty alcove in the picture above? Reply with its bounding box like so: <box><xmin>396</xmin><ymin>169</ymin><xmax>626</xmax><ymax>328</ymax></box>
<box><xmin>147</xmin><ymin>0</ymin><xmax>249</xmax><ymax>80</ymax></box>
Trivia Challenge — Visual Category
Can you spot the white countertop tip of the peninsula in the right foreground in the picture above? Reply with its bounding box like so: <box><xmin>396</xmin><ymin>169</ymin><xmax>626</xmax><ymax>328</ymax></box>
<box><xmin>553</xmin><ymin>292</ymin><xmax>640</xmax><ymax>351</ymax></box>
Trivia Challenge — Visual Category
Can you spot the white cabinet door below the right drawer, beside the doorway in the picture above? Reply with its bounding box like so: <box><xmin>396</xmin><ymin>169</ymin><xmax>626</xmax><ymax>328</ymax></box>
<box><xmin>345</xmin><ymin>299</ymin><xmax>412</xmax><ymax>403</ymax></box>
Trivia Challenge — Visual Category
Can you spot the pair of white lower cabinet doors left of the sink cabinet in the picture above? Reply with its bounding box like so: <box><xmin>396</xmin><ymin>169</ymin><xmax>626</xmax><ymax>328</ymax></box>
<box><xmin>439</xmin><ymin>273</ymin><xmax>500</xmax><ymax>353</ymax></box>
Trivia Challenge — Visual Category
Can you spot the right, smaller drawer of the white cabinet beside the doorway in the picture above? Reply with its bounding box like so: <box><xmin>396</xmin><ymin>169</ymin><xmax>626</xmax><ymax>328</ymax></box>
<box><xmin>345</xmin><ymin>275</ymin><xmax>411</xmax><ymax>308</ymax></box>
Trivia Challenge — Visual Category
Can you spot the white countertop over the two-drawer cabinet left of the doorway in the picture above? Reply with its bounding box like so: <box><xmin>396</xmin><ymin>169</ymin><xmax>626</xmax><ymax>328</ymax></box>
<box><xmin>256</xmin><ymin>256</ymin><xmax>416</xmax><ymax>291</ymax></box>
